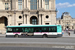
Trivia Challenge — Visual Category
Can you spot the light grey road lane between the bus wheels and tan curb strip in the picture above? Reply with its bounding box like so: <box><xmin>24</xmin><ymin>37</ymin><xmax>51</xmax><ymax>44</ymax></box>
<box><xmin>0</xmin><ymin>37</ymin><xmax>75</xmax><ymax>45</ymax></box>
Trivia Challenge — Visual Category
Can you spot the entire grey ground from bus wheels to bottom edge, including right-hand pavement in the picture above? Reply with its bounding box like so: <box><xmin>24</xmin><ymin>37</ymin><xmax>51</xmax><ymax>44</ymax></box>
<box><xmin>0</xmin><ymin>32</ymin><xmax>75</xmax><ymax>50</ymax></box>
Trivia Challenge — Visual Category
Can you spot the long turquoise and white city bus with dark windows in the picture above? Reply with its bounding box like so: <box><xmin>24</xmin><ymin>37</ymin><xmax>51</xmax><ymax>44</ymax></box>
<box><xmin>6</xmin><ymin>25</ymin><xmax>62</xmax><ymax>38</ymax></box>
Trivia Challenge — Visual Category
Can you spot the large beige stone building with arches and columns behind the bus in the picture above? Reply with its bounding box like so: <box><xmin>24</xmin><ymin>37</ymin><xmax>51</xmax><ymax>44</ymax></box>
<box><xmin>0</xmin><ymin>0</ymin><xmax>56</xmax><ymax>31</ymax></box>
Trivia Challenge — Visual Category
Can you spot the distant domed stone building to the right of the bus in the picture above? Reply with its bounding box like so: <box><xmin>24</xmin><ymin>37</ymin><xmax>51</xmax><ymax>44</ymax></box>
<box><xmin>57</xmin><ymin>12</ymin><xmax>75</xmax><ymax>30</ymax></box>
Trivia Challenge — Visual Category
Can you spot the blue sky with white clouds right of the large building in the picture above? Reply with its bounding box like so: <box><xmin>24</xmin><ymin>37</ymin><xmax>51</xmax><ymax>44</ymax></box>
<box><xmin>56</xmin><ymin>0</ymin><xmax>75</xmax><ymax>18</ymax></box>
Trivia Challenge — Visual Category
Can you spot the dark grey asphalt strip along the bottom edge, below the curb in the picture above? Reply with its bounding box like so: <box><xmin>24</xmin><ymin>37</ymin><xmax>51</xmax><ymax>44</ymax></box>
<box><xmin>0</xmin><ymin>47</ymin><xmax>73</xmax><ymax>50</ymax></box>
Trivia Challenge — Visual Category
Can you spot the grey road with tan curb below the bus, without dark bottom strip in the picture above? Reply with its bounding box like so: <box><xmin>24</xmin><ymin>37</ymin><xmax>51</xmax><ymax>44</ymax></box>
<box><xmin>0</xmin><ymin>38</ymin><xmax>75</xmax><ymax>49</ymax></box>
